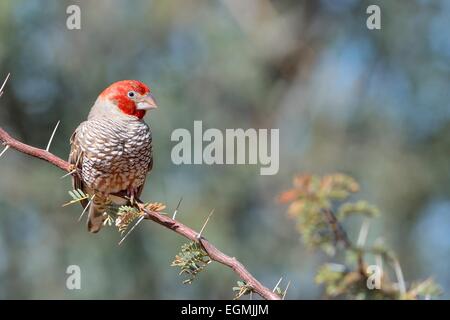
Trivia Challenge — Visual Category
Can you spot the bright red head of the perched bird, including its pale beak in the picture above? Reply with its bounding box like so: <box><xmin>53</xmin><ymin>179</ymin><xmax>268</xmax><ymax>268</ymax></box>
<box><xmin>99</xmin><ymin>80</ymin><xmax>157</xmax><ymax>119</ymax></box>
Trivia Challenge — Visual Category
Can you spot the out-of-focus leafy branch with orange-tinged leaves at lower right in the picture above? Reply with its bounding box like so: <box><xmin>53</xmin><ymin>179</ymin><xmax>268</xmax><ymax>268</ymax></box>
<box><xmin>279</xmin><ymin>174</ymin><xmax>441</xmax><ymax>299</ymax></box>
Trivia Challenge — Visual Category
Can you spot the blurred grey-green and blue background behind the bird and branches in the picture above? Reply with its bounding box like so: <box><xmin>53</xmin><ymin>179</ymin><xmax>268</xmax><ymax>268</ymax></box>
<box><xmin>0</xmin><ymin>0</ymin><xmax>450</xmax><ymax>299</ymax></box>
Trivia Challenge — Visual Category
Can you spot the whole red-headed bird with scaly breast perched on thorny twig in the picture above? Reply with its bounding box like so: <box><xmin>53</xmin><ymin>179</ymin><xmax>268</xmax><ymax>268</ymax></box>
<box><xmin>69</xmin><ymin>80</ymin><xmax>157</xmax><ymax>233</ymax></box>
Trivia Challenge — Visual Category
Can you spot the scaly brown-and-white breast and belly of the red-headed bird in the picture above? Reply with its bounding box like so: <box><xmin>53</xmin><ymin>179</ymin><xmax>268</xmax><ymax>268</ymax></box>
<box><xmin>78</xmin><ymin>118</ymin><xmax>152</xmax><ymax>193</ymax></box>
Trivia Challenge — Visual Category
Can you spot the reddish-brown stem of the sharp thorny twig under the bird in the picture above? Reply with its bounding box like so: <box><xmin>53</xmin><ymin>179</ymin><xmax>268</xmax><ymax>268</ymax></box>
<box><xmin>0</xmin><ymin>128</ymin><xmax>280</xmax><ymax>300</ymax></box>
